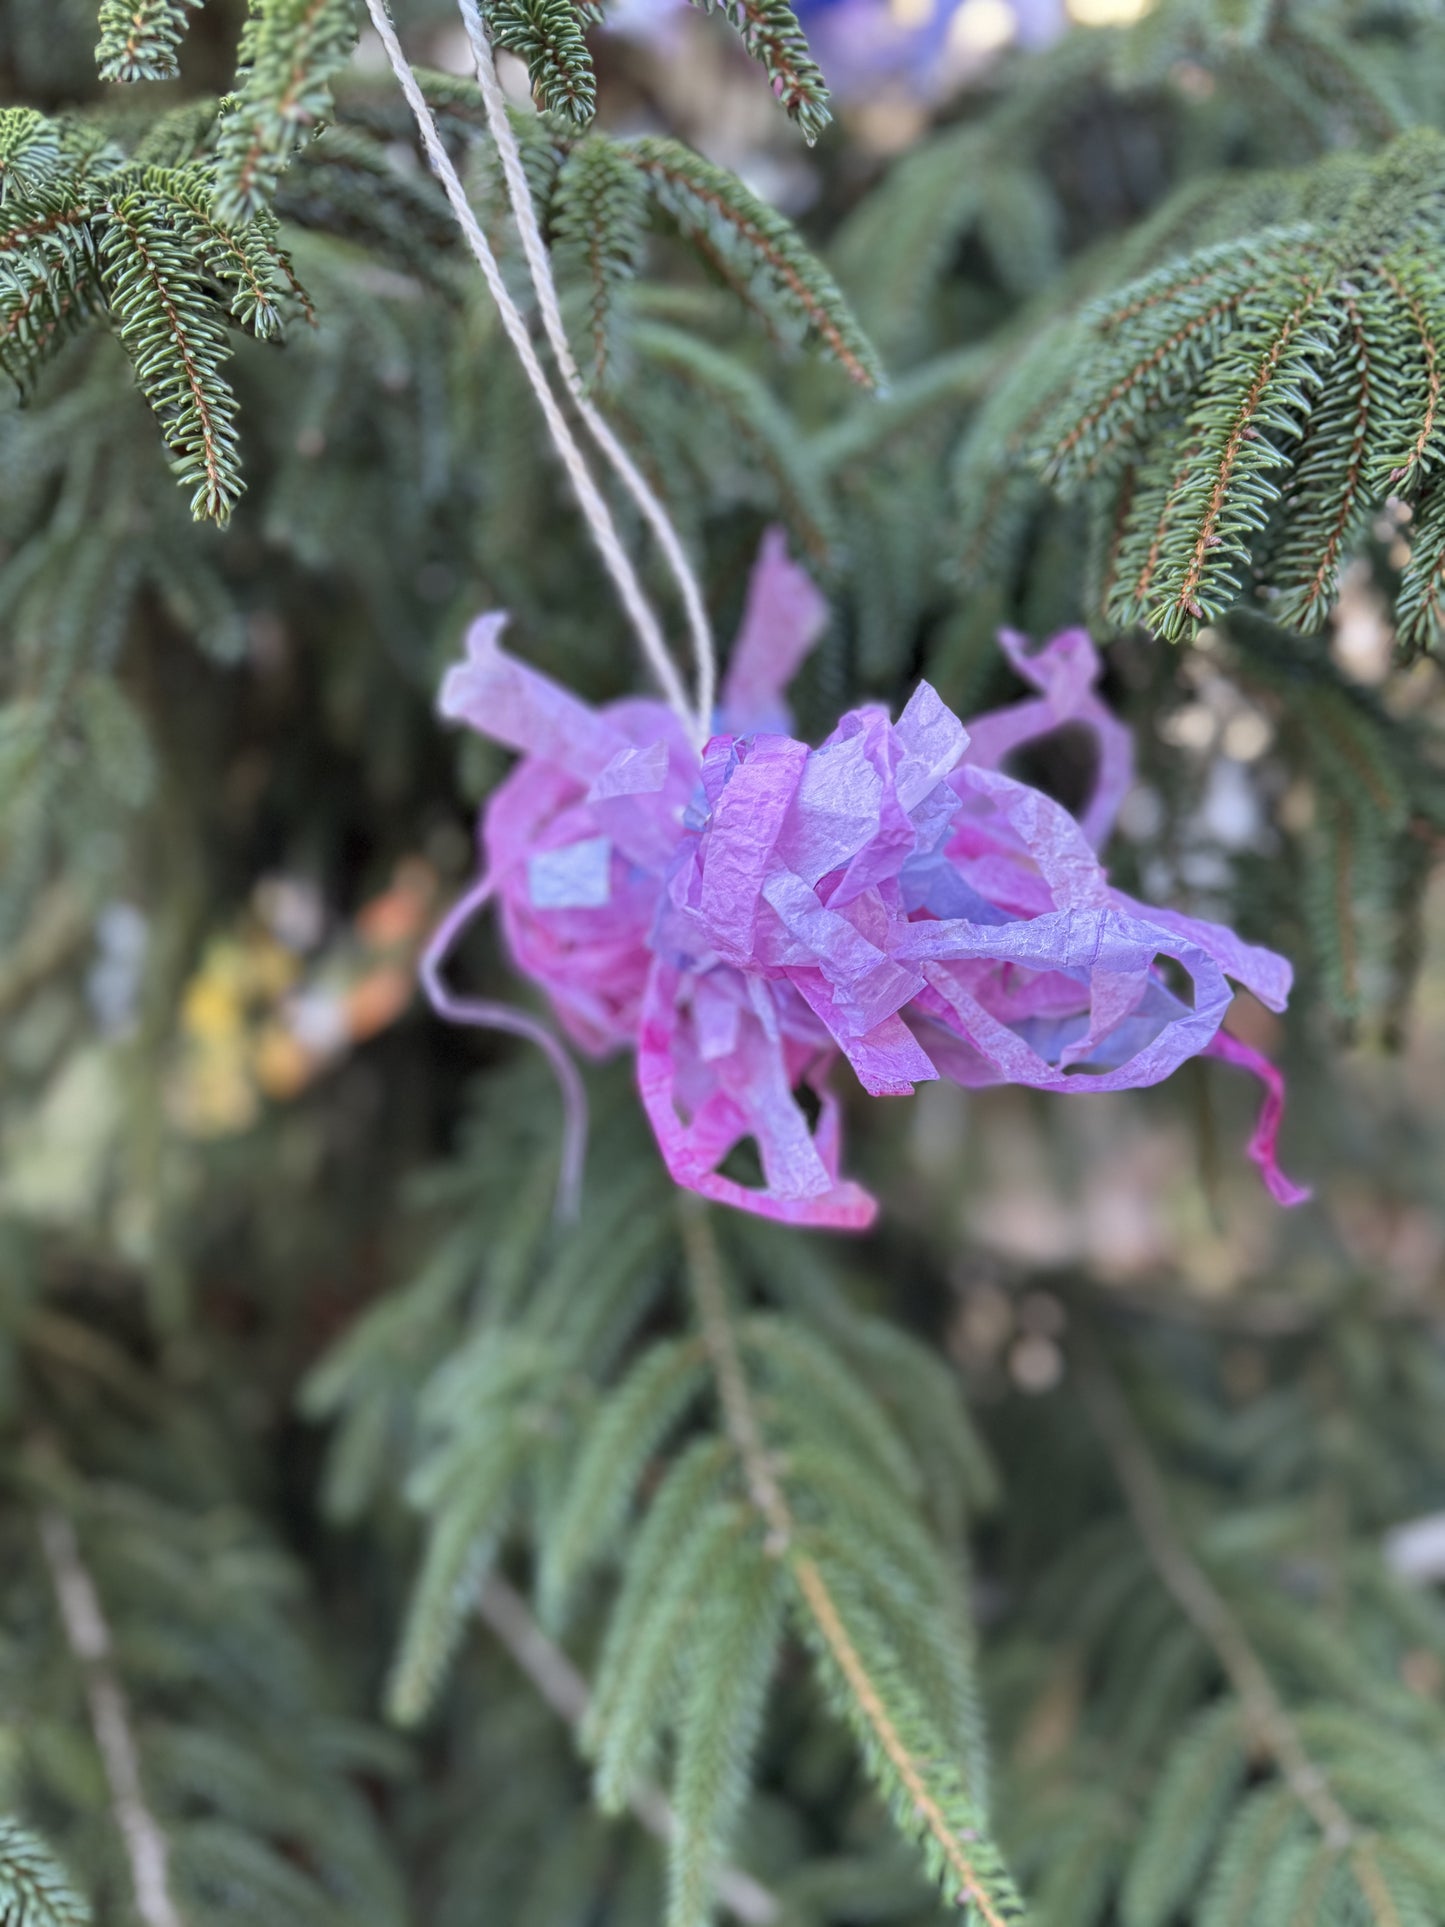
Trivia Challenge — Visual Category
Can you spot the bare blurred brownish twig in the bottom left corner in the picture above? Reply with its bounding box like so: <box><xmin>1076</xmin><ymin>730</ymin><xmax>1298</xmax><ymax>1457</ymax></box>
<box><xmin>39</xmin><ymin>1507</ymin><xmax>185</xmax><ymax>1927</ymax></box>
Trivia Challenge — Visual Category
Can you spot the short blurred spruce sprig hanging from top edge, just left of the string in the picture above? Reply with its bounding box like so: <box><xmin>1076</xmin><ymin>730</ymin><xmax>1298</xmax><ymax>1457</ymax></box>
<box><xmin>216</xmin><ymin>0</ymin><xmax>356</xmax><ymax>225</ymax></box>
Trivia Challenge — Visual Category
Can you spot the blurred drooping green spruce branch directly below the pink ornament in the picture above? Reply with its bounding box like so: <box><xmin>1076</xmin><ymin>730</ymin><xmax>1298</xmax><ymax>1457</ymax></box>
<box><xmin>327</xmin><ymin>1085</ymin><xmax>1010</xmax><ymax>1927</ymax></box>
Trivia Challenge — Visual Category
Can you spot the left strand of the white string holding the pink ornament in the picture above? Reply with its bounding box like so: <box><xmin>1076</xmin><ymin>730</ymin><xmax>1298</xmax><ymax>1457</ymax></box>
<box><xmin>366</xmin><ymin>0</ymin><xmax>701</xmax><ymax>748</ymax></box>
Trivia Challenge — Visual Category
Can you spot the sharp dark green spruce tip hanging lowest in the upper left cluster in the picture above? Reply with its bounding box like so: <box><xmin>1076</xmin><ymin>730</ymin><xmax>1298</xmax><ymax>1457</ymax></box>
<box><xmin>100</xmin><ymin>193</ymin><xmax>243</xmax><ymax>522</ymax></box>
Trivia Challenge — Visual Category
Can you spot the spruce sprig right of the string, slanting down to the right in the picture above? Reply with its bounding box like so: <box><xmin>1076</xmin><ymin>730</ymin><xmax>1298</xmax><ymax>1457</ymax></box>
<box><xmin>624</xmin><ymin>135</ymin><xmax>882</xmax><ymax>387</ymax></box>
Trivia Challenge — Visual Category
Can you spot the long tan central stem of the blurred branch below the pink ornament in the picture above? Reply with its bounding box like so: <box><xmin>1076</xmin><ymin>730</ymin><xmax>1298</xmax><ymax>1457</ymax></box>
<box><xmin>680</xmin><ymin>1201</ymin><xmax>1019</xmax><ymax>1927</ymax></box>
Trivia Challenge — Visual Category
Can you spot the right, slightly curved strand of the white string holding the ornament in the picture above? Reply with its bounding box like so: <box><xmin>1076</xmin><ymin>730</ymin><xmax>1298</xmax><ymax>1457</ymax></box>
<box><xmin>457</xmin><ymin>0</ymin><xmax>717</xmax><ymax>732</ymax></box>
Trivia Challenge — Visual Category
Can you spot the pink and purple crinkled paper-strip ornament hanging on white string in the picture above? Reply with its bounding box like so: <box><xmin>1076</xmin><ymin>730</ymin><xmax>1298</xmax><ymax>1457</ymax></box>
<box><xmin>426</xmin><ymin>530</ymin><xmax>1306</xmax><ymax>1229</ymax></box>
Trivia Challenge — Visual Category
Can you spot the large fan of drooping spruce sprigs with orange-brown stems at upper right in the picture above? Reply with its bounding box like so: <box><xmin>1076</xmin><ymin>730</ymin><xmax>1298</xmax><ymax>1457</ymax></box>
<box><xmin>1009</xmin><ymin>131</ymin><xmax>1445</xmax><ymax>644</ymax></box>
